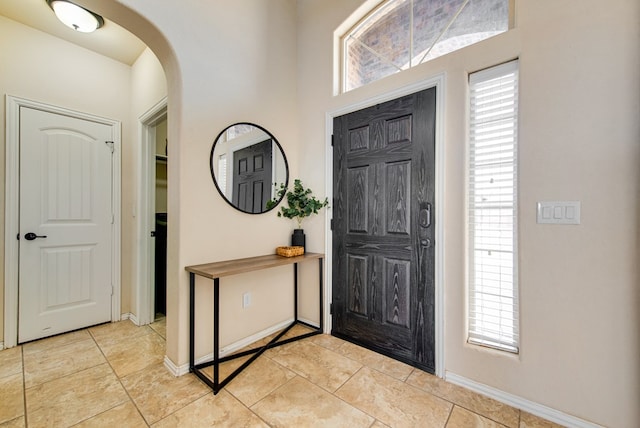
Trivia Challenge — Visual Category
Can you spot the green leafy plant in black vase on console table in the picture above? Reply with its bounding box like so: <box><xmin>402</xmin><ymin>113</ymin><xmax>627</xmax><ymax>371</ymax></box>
<box><xmin>267</xmin><ymin>178</ymin><xmax>329</xmax><ymax>251</ymax></box>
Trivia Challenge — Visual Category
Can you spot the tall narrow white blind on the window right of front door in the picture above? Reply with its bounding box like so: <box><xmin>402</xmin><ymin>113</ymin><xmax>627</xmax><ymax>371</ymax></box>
<box><xmin>468</xmin><ymin>61</ymin><xmax>519</xmax><ymax>352</ymax></box>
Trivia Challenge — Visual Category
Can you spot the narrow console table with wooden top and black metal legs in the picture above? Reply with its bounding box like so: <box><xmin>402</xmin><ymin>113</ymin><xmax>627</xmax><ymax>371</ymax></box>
<box><xmin>185</xmin><ymin>253</ymin><xmax>324</xmax><ymax>394</ymax></box>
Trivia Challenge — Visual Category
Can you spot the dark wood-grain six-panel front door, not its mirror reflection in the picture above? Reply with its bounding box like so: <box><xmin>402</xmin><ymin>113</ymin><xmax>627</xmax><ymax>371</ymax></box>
<box><xmin>332</xmin><ymin>88</ymin><xmax>436</xmax><ymax>373</ymax></box>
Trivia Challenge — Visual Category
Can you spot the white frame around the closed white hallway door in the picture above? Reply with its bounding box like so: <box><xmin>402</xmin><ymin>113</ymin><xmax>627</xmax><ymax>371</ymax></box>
<box><xmin>4</xmin><ymin>95</ymin><xmax>122</xmax><ymax>348</ymax></box>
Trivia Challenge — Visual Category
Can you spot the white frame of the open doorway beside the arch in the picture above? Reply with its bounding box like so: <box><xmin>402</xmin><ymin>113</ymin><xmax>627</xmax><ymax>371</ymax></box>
<box><xmin>137</xmin><ymin>97</ymin><xmax>169</xmax><ymax>325</ymax></box>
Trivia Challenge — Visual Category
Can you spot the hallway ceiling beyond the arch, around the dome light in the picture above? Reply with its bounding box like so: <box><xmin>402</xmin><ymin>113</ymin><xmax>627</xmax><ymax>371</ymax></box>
<box><xmin>0</xmin><ymin>0</ymin><xmax>146</xmax><ymax>65</ymax></box>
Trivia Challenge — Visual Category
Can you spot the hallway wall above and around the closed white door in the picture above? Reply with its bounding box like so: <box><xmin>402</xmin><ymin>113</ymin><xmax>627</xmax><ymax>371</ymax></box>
<box><xmin>0</xmin><ymin>16</ymin><xmax>132</xmax><ymax>341</ymax></box>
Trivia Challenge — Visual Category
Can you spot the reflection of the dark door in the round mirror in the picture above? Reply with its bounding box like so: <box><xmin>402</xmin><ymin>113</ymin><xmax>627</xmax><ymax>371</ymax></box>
<box><xmin>233</xmin><ymin>139</ymin><xmax>273</xmax><ymax>213</ymax></box>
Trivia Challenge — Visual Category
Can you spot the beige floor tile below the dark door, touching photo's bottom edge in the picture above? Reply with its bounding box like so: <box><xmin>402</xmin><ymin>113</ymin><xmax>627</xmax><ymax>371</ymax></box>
<box><xmin>336</xmin><ymin>367</ymin><xmax>452</xmax><ymax>427</ymax></box>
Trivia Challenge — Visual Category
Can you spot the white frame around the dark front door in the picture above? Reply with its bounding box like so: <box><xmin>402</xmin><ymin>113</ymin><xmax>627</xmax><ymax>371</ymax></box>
<box><xmin>324</xmin><ymin>73</ymin><xmax>446</xmax><ymax>378</ymax></box>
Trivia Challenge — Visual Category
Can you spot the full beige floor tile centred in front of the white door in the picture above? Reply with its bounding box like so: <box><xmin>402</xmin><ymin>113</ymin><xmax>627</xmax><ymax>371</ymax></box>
<box><xmin>24</xmin><ymin>337</ymin><xmax>106</xmax><ymax>388</ymax></box>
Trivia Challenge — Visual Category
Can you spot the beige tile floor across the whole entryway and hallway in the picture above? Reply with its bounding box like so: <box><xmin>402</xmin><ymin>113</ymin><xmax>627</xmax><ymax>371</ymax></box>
<box><xmin>0</xmin><ymin>320</ymin><xmax>558</xmax><ymax>428</ymax></box>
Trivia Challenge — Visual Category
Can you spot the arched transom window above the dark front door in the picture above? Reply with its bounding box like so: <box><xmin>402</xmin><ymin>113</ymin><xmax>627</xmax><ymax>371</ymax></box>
<box><xmin>342</xmin><ymin>0</ymin><xmax>509</xmax><ymax>92</ymax></box>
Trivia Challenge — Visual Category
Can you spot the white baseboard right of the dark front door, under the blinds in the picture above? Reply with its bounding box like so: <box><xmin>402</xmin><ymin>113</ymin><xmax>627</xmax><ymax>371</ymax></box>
<box><xmin>445</xmin><ymin>372</ymin><xmax>602</xmax><ymax>428</ymax></box>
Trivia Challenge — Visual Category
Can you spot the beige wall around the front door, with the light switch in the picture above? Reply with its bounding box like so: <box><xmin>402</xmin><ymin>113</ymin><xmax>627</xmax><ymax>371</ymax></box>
<box><xmin>298</xmin><ymin>0</ymin><xmax>640</xmax><ymax>427</ymax></box>
